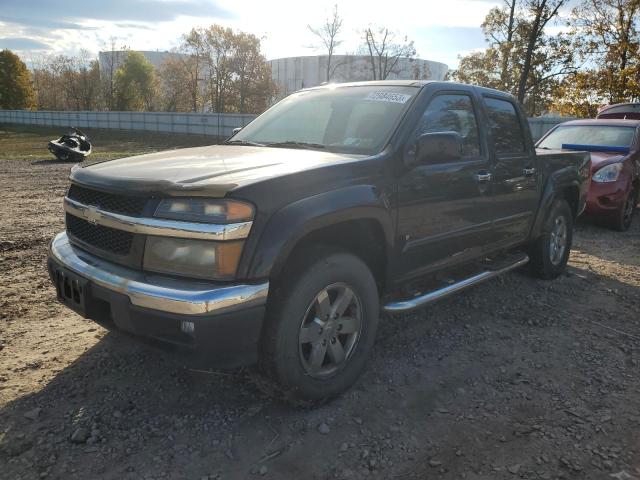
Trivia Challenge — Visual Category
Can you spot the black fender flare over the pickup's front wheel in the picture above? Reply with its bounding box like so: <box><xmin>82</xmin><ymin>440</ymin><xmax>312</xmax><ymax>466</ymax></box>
<box><xmin>248</xmin><ymin>185</ymin><xmax>394</xmax><ymax>278</ymax></box>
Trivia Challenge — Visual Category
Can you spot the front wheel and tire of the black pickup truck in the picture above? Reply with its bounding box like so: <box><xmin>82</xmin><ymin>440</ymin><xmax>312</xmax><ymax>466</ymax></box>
<box><xmin>261</xmin><ymin>249</ymin><xmax>379</xmax><ymax>403</ymax></box>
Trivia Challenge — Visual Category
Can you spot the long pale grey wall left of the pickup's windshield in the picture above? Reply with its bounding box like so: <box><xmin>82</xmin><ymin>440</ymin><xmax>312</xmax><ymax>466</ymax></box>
<box><xmin>0</xmin><ymin>110</ymin><xmax>255</xmax><ymax>137</ymax></box>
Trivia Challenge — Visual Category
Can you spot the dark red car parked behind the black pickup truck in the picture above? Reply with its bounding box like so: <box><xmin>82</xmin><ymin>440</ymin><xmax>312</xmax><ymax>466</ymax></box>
<box><xmin>536</xmin><ymin>119</ymin><xmax>640</xmax><ymax>230</ymax></box>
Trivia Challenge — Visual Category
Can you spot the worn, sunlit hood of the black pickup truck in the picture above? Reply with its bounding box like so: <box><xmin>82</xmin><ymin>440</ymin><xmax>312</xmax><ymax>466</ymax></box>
<box><xmin>70</xmin><ymin>145</ymin><xmax>363</xmax><ymax>197</ymax></box>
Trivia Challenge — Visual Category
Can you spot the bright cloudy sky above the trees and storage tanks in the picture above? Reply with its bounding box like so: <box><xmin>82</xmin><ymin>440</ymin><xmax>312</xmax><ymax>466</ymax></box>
<box><xmin>0</xmin><ymin>0</ymin><xmax>502</xmax><ymax>68</ymax></box>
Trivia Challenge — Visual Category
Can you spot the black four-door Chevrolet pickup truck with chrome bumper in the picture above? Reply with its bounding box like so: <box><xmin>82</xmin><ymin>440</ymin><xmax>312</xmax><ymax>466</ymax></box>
<box><xmin>48</xmin><ymin>81</ymin><xmax>590</xmax><ymax>400</ymax></box>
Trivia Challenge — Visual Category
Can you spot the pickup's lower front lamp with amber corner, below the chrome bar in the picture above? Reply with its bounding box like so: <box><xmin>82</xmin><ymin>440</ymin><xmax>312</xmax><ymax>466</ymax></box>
<box><xmin>143</xmin><ymin>236</ymin><xmax>244</xmax><ymax>280</ymax></box>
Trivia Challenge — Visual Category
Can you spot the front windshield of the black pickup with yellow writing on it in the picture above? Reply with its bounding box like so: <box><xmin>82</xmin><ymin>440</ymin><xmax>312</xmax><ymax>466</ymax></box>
<box><xmin>228</xmin><ymin>85</ymin><xmax>418</xmax><ymax>155</ymax></box>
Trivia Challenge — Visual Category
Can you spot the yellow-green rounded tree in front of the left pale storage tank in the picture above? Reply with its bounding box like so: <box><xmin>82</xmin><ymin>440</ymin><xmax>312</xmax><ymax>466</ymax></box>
<box><xmin>115</xmin><ymin>52</ymin><xmax>157</xmax><ymax>111</ymax></box>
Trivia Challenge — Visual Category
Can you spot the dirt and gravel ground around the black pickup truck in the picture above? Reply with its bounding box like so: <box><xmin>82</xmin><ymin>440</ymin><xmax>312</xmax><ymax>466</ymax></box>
<box><xmin>0</xmin><ymin>127</ymin><xmax>640</xmax><ymax>480</ymax></box>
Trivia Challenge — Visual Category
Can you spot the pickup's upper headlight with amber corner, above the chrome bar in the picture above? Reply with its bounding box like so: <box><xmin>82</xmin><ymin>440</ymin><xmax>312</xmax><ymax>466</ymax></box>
<box><xmin>154</xmin><ymin>198</ymin><xmax>253</xmax><ymax>224</ymax></box>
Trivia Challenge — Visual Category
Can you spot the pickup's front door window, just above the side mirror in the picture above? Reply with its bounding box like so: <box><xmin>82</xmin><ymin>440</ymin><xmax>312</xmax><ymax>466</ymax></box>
<box><xmin>416</xmin><ymin>94</ymin><xmax>480</xmax><ymax>157</ymax></box>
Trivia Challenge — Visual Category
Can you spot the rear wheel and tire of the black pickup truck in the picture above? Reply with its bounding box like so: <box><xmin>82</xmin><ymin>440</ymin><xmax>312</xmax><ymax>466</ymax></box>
<box><xmin>529</xmin><ymin>199</ymin><xmax>573</xmax><ymax>280</ymax></box>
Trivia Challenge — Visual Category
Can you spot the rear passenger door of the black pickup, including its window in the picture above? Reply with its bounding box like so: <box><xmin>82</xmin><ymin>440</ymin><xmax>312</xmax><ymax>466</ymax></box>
<box><xmin>482</xmin><ymin>95</ymin><xmax>538</xmax><ymax>249</ymax></box>
